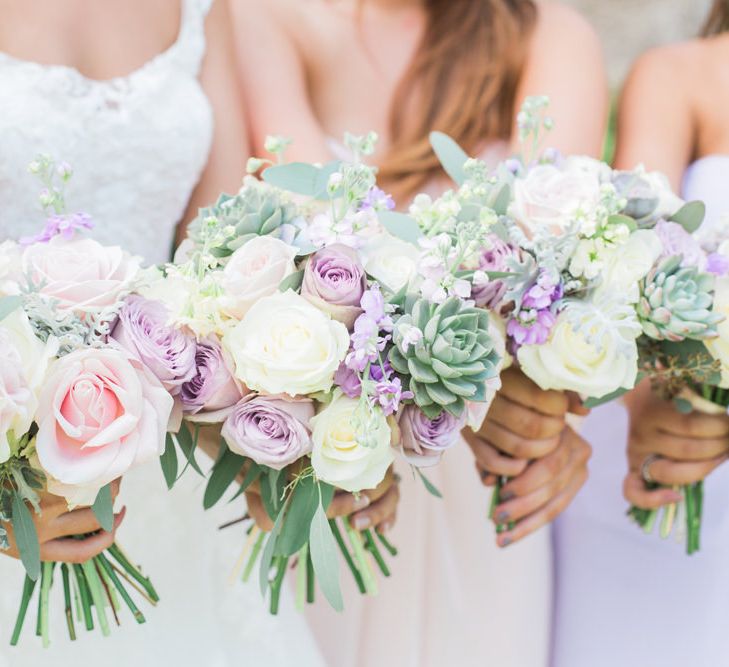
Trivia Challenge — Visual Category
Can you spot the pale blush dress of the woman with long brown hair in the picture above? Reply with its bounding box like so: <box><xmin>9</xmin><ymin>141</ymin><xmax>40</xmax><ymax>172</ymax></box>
<box><xmin>307</xmin><ymin>139</ymin><xmax>552</xmax><ymax>667</ymax></box>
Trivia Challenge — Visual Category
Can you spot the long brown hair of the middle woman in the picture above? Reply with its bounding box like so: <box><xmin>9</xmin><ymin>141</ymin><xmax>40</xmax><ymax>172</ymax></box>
<box><xmin>379</xmin><ymin>0</ymin><xmax>536</xmax><ymax>203</ymax></box>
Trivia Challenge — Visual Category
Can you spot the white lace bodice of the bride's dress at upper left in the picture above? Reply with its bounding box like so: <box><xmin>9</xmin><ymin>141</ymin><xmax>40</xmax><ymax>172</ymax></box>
<box><xmin>0</xmin><ymin>0</ymin><xmax>213</xmax><ymax>262</ymax></box>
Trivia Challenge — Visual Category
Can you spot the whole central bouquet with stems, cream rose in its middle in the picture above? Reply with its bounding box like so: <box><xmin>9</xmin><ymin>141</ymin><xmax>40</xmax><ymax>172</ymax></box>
<box><xmin>154</xmin><ymin>135</ymin><xmax>501</xmax><ymax>613</ymax></box>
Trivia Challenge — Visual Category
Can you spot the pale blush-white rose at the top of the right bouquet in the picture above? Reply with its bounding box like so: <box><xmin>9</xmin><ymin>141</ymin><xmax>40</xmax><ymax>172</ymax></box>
<box><xmin>510</xmin><ymin>163</ymin><xmax>601</xmax><ymax>234</ymax></box>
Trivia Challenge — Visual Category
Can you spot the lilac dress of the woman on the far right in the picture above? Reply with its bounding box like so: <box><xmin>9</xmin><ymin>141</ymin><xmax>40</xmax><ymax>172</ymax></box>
<box><xmin>552</xmin><ymin>156</ymin><xmax>729</xmax><ymax>667</ymax></box>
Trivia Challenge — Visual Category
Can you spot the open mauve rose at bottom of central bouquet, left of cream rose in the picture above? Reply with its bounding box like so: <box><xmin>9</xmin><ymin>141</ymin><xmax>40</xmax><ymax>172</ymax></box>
<box><xmin>222</xmin><ymin>394</ymin><xmax>314</xmax><ymax>470</ymax></box>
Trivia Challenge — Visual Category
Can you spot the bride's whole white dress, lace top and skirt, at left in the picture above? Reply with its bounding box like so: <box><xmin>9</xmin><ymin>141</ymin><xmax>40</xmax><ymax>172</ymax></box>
<box><xmin>0</xmin><ymin>0</ymin><xmax>321</xmax><ymax>667</ymax></box>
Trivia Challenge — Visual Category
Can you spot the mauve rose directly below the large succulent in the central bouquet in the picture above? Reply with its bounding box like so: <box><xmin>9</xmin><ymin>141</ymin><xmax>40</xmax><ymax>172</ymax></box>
<box><xmin>400</xmin><ymin>405</ymin><xmax>466</xmax><ymax>468</ymax></box>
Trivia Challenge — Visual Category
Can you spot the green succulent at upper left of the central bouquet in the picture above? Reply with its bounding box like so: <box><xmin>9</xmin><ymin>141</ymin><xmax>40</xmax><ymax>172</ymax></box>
<box><xmin>188</xmin><ymin>178</ymin><xmax>298</xmax><ymax>258</ymax></box>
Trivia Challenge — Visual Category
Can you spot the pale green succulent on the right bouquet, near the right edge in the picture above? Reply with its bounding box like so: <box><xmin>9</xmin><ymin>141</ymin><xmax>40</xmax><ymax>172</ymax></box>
<box><xmin>637</xmin><ymin>256</ymin><xmax>724</xmax><ymax>342</ymax></box>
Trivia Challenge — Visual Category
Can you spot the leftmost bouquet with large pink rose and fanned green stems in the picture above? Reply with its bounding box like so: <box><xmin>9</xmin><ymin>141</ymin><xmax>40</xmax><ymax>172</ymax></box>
<box><xmin>0</xmin><ymin>156</ymin><xmax>172</xmax><ymax>646</ymax></box>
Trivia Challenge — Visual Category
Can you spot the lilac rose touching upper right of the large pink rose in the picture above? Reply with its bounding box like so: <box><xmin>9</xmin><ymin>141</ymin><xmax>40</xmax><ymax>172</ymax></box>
<box><xmin>111</xmin><ymin>296</ymin><xmax>197</xmax><ymax>396</ymax></box>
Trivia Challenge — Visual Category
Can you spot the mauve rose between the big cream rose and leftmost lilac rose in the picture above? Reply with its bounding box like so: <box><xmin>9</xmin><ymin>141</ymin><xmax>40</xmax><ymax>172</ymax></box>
<box><xmin>180</xmin><ymin>338</ymin><xmax>243</xmax><ymax>422</ymax></box>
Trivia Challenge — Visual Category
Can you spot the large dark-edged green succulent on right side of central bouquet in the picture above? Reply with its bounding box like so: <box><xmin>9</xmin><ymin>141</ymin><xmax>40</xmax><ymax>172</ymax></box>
<box><xmin>389</xmin><ymin>297</ymin><xmax>501</xmax><ymax>419</ymax></box>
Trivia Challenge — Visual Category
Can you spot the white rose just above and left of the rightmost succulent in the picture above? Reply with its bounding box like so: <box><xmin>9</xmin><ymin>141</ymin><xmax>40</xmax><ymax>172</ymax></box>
<box><xmin>598</xmin><ymin>229</ymin><xmax>663</xmax><ymax>303</ymax></box>
